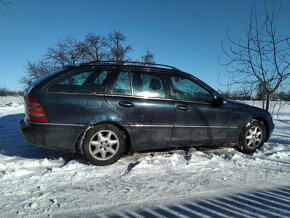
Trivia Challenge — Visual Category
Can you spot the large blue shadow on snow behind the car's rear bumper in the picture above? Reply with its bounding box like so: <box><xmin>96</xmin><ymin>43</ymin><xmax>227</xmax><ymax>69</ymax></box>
<box><xmin>0</xmin><ymin>113</ymin><xmax>81</xmax><ymax>163</ymax></box>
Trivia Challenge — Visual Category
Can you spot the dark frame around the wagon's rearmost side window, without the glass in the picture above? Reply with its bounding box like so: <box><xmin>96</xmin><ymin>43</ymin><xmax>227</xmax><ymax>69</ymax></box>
<box><xmin>43</xmin><ymin>67</ymin><xmax>115</xmax><ymax>95</ymax></box>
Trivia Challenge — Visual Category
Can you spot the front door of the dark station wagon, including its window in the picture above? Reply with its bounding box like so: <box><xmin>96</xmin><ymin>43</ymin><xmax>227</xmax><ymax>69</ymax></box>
<box><xmin>170</xmin><ymin>75</ymin><xmax>231</xmax><ymax>146</ymax></box>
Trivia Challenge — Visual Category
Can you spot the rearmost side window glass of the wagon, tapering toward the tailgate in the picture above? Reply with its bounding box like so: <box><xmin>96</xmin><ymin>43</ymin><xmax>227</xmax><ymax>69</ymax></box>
<box><xmin>49</xmin><ymin>71</ymin><xmax>109</xmax><ymax>93</ymax></box>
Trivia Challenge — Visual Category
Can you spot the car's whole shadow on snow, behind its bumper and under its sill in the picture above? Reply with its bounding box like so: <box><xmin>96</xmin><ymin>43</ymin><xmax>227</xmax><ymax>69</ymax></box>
<box><xmin>0</xmin><ymin>113</ymin><xmax>219</xmax><ymax>166</ymax></box>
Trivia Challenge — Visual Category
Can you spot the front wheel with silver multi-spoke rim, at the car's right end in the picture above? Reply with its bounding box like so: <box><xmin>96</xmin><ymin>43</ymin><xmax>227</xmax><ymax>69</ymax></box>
<box><xmin>238</xmin><ymin>120</ymin><xmax>266</xmax><ymax>154</ymax></box>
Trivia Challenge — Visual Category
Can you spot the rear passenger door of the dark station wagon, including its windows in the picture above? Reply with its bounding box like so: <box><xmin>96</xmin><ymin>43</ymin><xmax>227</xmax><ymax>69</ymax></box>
<box><xmin>106</xmin><ymin>70</ymin><xmax>175</xmax><ymax>150</ymax></box>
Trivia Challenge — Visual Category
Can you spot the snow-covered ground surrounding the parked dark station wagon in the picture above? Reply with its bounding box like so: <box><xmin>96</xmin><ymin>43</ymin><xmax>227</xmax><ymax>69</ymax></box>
<box><xmin>0</xmin><ymin>97</ymin><xmax>290</xmax><ymax>217</ymax></box>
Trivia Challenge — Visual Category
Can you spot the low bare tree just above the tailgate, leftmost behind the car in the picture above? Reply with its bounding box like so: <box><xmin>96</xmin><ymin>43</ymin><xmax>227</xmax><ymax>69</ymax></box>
<box><xmin>19</xmin><ymin>60</ymin><xmax>55</xmax><ymax>85</ymax></box>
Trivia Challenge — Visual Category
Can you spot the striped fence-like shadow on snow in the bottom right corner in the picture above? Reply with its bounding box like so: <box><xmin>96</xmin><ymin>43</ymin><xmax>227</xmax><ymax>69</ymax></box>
<box><xmin>108</xmin><ymin>186</ymin><xmax>290</xmax><ymax>218</ymax></box>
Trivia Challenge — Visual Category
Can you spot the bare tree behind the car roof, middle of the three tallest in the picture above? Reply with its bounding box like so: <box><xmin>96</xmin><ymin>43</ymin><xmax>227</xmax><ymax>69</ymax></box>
<box><xmin>80</xmin><ymin>33</ymin><xmax>108</xmax><ymax>61</ymax></box>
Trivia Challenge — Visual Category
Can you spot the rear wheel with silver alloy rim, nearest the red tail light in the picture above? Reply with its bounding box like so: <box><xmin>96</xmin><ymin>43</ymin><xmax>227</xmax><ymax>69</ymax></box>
<box><xmin>81</xmin><ymin>124</ymin><xmax>126</xmax><ymax>166</ymax></box>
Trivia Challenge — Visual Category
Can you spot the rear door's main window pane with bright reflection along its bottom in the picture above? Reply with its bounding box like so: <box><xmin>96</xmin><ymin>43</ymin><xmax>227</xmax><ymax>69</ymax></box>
<box><xmin>131</xmin><ymin>72</ymin><xmax>166</xmax><ymax>98</ymax></box>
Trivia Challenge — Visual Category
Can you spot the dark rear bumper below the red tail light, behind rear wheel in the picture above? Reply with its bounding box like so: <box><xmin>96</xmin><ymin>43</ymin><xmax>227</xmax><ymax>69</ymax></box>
<box><xmin>18</xmin><ymin>120</ymin><xmax>86</xmax><ymax>152</ymax></box>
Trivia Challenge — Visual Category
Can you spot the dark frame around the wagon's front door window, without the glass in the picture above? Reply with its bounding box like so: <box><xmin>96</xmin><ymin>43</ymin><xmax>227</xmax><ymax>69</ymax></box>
<box><xmin>168</xmin><ymin>73</ymin><xmax>216</xmax><ymax>104</ymax></box>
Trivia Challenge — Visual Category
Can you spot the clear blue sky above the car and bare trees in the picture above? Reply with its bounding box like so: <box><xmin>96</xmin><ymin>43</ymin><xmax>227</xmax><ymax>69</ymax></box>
<box><xmin>0</xmin><ymin>0</ymin><xmax>290</xmax><ymax>90</ymax></box>
